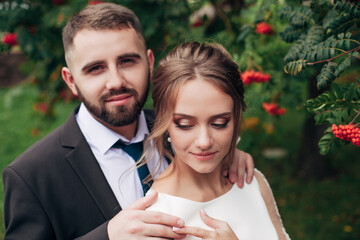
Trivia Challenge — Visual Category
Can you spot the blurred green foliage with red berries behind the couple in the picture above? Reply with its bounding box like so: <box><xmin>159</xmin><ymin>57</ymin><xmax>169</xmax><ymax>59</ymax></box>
<box><xmin>0</xmin><ymin>0</ymin><xmax>360</xmax><ymax>239</ymax></box>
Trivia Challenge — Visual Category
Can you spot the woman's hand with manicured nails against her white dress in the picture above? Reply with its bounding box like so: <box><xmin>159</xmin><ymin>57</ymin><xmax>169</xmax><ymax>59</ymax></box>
<box><xmin>173</xmin><ymin>210</ymin><xmax>238</xmax><ymax>240</ymax></box>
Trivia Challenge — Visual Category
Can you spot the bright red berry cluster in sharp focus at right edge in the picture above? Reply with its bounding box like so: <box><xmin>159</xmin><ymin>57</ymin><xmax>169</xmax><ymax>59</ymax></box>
<box><xmin>331</xmin><ymin>123</ymin><xmax>360</xmax><ymax>147</ymax></box>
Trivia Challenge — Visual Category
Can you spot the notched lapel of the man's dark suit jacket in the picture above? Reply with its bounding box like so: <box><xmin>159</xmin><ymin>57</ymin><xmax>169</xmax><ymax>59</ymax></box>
<box><xmin>62</xmin><ymin>108</ymin><xmax>121</xmax><ymax>220</ymax></box>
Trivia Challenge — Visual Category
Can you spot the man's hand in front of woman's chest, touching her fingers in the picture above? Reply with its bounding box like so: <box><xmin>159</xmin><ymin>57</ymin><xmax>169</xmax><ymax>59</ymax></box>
<box><xmin>107</xmin><ymin>192</ymin><xmax>186</xmax><ymax>240</ymax></box>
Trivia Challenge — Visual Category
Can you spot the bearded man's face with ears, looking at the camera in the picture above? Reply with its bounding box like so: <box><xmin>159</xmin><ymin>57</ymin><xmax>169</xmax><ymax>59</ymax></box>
<box><xmin>62</xmin><ymin>28</ymin><xmax>154</xmax><ymax>127</ymax></box>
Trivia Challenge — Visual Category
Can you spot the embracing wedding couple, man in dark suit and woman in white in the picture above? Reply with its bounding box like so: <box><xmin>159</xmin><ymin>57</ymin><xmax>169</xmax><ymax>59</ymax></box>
<box><xmin>3</xmin><ymin>3</ymin><xmax>289</xmax><ymax>240</ymax></box>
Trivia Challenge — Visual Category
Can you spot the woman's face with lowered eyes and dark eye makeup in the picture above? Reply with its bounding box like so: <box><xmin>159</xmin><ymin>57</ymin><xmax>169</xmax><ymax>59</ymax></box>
<box><xmin>168</xmin><ymin>78</ymin><xmax>234</xmax><ymax>173</ymax></box>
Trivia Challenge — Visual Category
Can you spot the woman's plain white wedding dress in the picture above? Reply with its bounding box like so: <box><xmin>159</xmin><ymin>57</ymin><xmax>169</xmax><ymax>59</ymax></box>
<box><xmin>146</xmin><ymin>170</ymin><xmax>289</xmax><ymax>240</ymax></box>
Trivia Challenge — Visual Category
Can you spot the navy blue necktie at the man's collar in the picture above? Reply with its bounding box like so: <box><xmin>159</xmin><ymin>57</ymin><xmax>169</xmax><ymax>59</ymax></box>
<box><xmin>112</xmin><ymin>140</ymin><xmax>153</xmax><ymax>195</ymax></box>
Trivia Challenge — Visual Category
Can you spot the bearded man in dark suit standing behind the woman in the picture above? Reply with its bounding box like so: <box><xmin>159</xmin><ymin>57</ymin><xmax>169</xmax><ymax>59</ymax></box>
<box><xmin>3</xmin><ymin>3</ymin><xmax>253</xmax><ymax>240</ymax></box>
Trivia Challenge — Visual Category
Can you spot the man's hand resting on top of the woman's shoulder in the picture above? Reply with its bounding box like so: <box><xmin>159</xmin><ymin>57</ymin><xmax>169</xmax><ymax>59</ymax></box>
<box><xmin>224</xmin><ymin>148</ymin><xmax>254</xmax><ymax>188</ymax></box>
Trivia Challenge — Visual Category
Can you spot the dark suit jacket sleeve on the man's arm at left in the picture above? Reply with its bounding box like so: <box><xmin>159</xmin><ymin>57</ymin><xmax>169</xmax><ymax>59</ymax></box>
<box><xmin>3</xmin><ymin>167</ymin><xmax>109</xmax><ymax>240</ymax></box>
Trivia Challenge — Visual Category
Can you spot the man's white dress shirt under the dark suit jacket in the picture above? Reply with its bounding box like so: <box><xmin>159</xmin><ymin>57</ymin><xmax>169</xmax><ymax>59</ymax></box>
<box><xmin>76</xmin><ymin>104</ymin><xmax>168</xmax><ymax>208</ymax></box>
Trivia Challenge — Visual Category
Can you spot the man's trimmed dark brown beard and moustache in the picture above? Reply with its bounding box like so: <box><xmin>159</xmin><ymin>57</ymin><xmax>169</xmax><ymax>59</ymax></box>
<box><xmin>75</xmin><ymin>74</ymin><xmax>150</xmax><ymax>127</ymax></box>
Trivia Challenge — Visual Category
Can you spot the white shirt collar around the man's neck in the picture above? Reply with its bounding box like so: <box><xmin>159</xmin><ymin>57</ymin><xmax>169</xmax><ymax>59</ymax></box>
<box><xmin>76</xmin><ymin>103</ymin><xmax>149</xmax><ymax>154</ymax></box>
